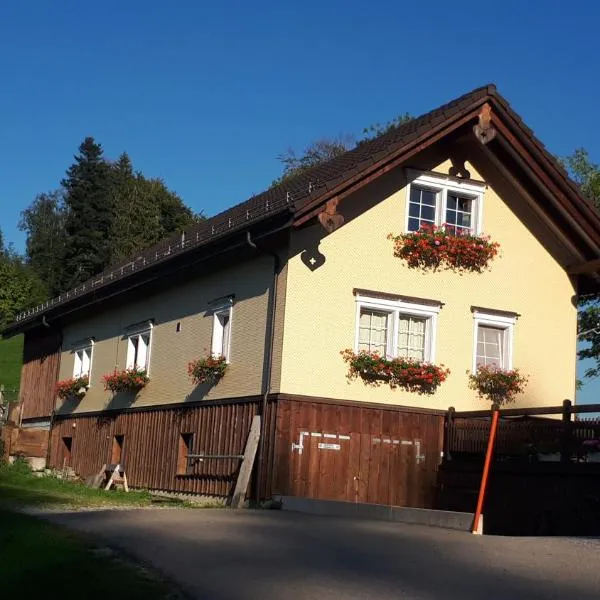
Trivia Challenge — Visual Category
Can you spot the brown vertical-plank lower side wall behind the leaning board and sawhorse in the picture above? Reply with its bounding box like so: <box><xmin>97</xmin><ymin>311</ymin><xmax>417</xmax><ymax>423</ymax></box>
<box><xmin>50</xmin><ymin>397</ymin><xmax>275</xmax><ymax>497</ymax></box>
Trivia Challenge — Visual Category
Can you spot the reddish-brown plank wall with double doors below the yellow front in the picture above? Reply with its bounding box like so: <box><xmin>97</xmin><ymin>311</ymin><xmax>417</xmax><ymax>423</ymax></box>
<box><xmin>273</xmin><ymin>399</ymin><xmax>444</xmax><ymax>508</ymax></box>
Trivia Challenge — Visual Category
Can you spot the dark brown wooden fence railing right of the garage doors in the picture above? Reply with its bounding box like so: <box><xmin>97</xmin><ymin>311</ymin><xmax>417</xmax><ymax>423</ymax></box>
<box><xmin>444</xmin><ymin>400</ymin><xmax>600</xmax><ymax>462</ymax></box>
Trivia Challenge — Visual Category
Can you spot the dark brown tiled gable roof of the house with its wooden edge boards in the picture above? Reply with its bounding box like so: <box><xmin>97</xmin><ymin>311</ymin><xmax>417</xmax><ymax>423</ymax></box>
<box><xmin>4</xmin><ymin>84</ymin><xmax>600</xmax><ymax>334</ymax></box>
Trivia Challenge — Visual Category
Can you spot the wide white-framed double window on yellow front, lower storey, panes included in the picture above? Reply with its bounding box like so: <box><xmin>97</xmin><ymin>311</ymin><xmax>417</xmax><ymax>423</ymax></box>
<box><xmin>355</xmin><ymin>295</ymin><xmax>440</xmax><ymax>362</ymax></box>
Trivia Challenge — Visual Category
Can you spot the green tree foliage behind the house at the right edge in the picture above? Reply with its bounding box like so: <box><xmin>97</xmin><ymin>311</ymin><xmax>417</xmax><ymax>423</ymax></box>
<box><xmin>562</xmin><ymin>148</ymin><xmax>600</xmax><ymax>378</ymax></box>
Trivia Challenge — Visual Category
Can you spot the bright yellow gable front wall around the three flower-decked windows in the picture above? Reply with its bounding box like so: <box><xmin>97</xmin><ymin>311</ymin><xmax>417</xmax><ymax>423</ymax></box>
<box><xmin>281</xmin><ymin>151</ymin><xmax>576</xmax><ymax>410</ymax></box>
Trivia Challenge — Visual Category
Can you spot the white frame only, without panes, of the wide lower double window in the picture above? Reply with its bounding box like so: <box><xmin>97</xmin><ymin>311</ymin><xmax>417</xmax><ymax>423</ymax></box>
<box><xmin>354</xmin><ymin>294</ymin><xmax>441</xmax><ymax>363</ymax></box>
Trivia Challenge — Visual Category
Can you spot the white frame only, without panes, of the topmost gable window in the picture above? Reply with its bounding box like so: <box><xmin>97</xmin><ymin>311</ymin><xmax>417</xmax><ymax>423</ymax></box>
<box><xmin>404</xmin><ymin>169</ymin><xmax>486</xmax><ymax>235</ymax></box>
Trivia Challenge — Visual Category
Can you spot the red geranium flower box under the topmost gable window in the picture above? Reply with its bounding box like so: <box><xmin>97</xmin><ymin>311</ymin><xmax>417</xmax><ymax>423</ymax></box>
<box><xmin>388</xmin><ymin>225</ymin><xmax>500</xmax><ymax>273</ymax></box>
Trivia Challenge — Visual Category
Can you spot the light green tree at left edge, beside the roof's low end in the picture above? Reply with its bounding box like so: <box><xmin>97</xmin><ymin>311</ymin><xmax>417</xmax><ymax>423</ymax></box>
<box><xmin>0</xmin><ymin>233</ymin><xmax>47</xmax><ymax>329</ymax></box>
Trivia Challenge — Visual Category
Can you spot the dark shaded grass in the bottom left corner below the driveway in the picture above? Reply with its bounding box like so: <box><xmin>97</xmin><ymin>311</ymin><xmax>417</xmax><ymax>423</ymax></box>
<box><xmin>0</xmin><ymin>509</ymin><xmax>182</xmax><ymax>600</ymax></box>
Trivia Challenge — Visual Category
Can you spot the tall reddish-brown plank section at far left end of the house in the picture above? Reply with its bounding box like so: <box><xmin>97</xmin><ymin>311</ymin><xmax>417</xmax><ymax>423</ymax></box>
<box><xmin>20</xmin><ymin>333</ymin><xmax>61</xmax><ymax>419</ymax></box>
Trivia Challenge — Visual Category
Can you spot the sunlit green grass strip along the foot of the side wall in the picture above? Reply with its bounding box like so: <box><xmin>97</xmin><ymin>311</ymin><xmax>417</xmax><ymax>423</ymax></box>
<box><xmin>0</xmin><ymin>462</ymin><xmax>192</xmax><ymax>508</ymax></box>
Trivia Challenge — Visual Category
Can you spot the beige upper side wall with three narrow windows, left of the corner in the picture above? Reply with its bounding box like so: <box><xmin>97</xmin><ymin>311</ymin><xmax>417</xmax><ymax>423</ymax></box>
<box><xmin>57</xmin><ymin>256</ymin><xmax>274</xmax><ymax>412</ymax></box>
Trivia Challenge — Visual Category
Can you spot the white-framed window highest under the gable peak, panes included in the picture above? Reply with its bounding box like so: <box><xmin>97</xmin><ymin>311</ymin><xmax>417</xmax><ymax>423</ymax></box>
<box><xmin>406</xmin><ymin>172</ymin><xmax>485</xmax><ymax>234</ymax></box>
